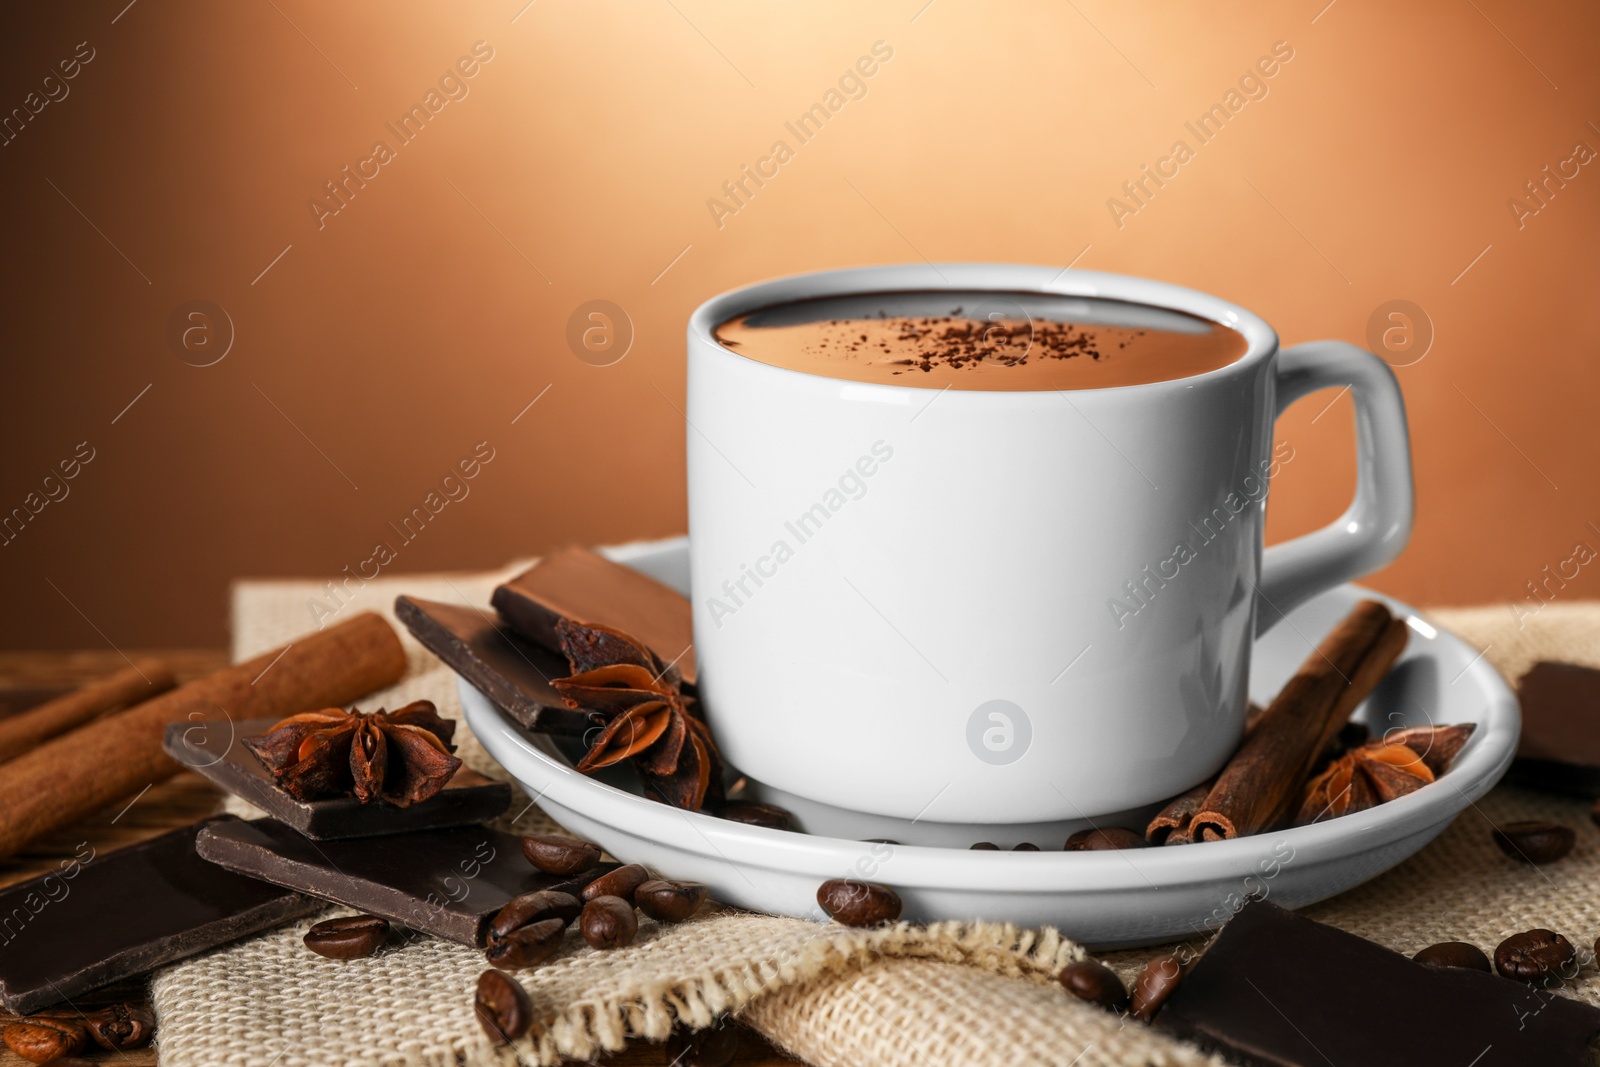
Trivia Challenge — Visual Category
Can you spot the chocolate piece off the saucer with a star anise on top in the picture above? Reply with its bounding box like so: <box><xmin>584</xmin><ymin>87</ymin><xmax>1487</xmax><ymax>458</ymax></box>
<box><xmin>163</xmin><ymin>718</ymin><xmax>510</xmax><ymax>841</ymax></box>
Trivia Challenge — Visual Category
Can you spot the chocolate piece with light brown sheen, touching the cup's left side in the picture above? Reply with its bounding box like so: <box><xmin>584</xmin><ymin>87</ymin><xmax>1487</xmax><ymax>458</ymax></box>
<box><xmin>490</xmin><ymin>547</ymin><xmax>694</xmax><ymax>685</ymax></box>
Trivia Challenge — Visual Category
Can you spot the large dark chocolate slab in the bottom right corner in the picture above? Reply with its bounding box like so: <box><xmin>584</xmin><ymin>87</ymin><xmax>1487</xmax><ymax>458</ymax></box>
<box><xmin>1155</xmin><ymin>901</ymin><xmax>1600</xmax><ymax>1067</ymax></box>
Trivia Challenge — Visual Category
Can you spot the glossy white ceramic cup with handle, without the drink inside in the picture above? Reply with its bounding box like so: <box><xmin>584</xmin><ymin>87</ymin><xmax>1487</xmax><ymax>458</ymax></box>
<box><xmin>688</xmin><ymin>264</ymin><xmax>1413</xmax><ymax>840</ymax></box>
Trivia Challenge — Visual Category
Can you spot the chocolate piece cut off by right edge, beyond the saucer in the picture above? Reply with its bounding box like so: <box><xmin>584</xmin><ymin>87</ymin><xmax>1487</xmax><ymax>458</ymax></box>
<box><xmin>1506</xmin><ymin>661</ymin><xmax>1600</xmax><ymax>798</ymax></box>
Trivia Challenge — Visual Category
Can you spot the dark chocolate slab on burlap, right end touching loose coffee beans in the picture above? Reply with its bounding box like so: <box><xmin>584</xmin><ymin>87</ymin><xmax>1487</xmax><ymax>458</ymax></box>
<box><xmin>195</xmin><ymin>819</ymin><xmax>588</xmax><ymax>949</ymax></box>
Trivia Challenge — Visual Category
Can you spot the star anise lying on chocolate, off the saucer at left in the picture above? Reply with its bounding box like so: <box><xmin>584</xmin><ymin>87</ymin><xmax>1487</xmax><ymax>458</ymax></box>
<box><xmin>245</xmin><ymin>701</ymin><xmax>461</xmax><ymax>808</ymax></box>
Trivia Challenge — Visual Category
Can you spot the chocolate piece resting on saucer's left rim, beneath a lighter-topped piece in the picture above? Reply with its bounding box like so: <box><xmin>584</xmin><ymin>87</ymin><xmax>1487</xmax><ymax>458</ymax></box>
<box><xmin>395</xmin><ymin>597</ymin><xmax>592</xmax><ymax>737</ymax></box>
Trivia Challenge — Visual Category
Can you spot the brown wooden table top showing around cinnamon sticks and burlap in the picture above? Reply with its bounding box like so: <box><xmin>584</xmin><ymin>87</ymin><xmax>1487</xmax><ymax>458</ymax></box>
<box><xmin>0</xmin><ymin>648</ymin><xmax>800</xmax><ymax>1067</ymax></box>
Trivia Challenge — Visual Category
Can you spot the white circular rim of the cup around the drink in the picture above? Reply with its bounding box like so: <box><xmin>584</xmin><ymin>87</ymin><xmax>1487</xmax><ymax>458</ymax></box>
<box><xmin>688</xmin><ymin>262</ymin><xmax>1278</xmax><ymax>396</ymax></box>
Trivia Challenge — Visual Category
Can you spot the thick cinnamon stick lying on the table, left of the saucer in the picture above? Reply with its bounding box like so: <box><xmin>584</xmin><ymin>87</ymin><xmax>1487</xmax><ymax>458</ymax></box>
<box><xmin>0</xmin><ymin>613</ymin><xmax>405</xmax><ymax>859</ymax></box>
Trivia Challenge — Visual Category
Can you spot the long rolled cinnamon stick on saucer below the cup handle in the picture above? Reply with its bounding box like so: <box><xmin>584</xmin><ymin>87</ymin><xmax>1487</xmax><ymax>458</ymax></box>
<box><xmin>1190</xmin><ymin>600</ymin><xmax>1406</xmax><ymax>841</ymax></box>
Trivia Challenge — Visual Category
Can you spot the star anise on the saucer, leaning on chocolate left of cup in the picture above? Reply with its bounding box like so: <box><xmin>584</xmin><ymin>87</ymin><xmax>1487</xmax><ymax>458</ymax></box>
<box><xmin>552</xmin><ymin>619</ymin><xmax>722</xmax><ymax>811</ymax></box>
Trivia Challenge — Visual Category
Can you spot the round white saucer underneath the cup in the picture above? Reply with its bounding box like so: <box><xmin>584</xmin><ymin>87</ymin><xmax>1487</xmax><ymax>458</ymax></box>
<box><xmin>459</xmin><ymin>537</ymin><xmax>1522</xmax><ymax>949</ymax></box>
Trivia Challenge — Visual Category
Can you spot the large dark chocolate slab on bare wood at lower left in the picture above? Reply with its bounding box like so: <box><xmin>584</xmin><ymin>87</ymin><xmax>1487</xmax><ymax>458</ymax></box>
<box><xmin>0</xmin><ymin>816</ymin><xmax>325</xmax><ymax>1014</ymax></box>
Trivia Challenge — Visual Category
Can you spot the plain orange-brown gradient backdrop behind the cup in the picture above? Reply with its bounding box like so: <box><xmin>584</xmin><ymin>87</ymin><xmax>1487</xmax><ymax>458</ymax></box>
<box><xmin>0</xmin><ymin>0</ymin><xmax>1600</xmax><ymax>648</ymax></box>
